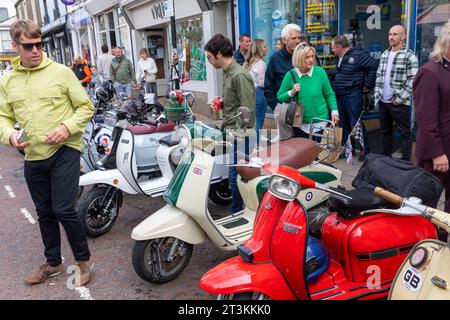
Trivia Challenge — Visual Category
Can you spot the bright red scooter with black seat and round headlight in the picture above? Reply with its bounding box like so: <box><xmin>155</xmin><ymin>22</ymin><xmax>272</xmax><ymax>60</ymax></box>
<box><xmin>200</xmin><ymin>164</ymin><xmax>437</xmax><ymax>300</ymax></box>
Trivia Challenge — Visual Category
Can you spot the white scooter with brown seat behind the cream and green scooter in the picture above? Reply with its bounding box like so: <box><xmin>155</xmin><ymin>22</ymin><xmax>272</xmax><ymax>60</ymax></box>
<box><xmin>77</xmin><ymin>110</ymin><xmax>231</xmax><ymax>238</ymax></box>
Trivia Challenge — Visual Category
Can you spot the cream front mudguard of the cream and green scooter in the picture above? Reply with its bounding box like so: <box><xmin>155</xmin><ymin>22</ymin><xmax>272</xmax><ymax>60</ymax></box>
<box><xmin>131</xmin><ymin>204</ymin><xmax>206</xmax><ymax>244</ymax></box>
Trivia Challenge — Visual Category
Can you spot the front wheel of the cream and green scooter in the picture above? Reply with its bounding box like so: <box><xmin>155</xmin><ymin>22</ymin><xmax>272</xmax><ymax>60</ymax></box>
<box><xmin>132</xmin><ymin>237</ymin><xmax>194</xmax><ymax>283</ymax></box>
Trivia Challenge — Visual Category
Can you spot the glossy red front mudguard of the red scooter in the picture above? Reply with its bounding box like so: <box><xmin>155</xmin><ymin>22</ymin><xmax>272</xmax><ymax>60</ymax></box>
<box><xmin>199</xmin><ymin>257</ymin><xmax>296</xmax><ymax>300</ymax></box>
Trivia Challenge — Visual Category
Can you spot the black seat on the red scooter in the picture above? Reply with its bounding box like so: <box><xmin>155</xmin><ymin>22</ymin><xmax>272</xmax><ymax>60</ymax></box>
<box><xmin>329</xmin><ymin>188</ymin><xmax>387</xmax><ymax>220</ymax></box>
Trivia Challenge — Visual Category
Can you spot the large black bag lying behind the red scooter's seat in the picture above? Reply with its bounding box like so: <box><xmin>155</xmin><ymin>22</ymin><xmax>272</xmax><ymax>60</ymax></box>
<box><xmin>352</xmin><ymin>153</ymin><xmax>443</xmax><ymax>207</ymax></box>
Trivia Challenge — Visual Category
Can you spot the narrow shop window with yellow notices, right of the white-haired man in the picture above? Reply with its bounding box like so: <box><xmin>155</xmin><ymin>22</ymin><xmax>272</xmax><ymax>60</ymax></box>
<box><xmin>305</xmin><ymin>0</ymin><xmax>338</xmax><ymax>69</ymax></box>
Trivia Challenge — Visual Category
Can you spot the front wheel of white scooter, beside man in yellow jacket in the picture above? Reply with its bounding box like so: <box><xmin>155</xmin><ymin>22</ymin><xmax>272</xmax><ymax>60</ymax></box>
<box><xmin>77</xmin><ymin>187</ymin><xmax>120</xmax><ymax>238</ymax></box>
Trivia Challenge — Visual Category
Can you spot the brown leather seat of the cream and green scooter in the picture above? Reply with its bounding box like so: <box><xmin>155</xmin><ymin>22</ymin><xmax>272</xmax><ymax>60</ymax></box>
<box><xmin>237</xmin><ymin>138</ymin><xmax>320</xmax><ymax>180</ymax></box>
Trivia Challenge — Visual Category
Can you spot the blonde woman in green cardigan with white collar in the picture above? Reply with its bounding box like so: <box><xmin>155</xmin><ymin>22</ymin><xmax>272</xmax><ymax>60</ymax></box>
<box><xmin>277</xmin><ymin>42</ymin><xmax>339</xmax><ymax>138</ymax></box>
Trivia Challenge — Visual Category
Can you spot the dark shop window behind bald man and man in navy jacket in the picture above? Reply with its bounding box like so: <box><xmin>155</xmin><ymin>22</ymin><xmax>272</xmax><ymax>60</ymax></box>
<box><xmin>342</xmin><ymin>0</ymin><xmax>407</xmax><ymax>59</ymax></box>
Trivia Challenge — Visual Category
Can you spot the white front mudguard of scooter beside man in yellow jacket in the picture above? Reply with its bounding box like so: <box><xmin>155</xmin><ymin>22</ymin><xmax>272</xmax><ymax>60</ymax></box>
<box><xmin>79</xmin><ymin>169</ymin><xmax>137</xmax><ymax>194</ymax></box>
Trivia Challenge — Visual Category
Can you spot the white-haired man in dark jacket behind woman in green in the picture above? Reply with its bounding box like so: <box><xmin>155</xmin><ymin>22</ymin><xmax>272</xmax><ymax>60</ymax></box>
<box><xmin>264</xmin><ymin>23</ymin><xmax>302</xmax><ymax>141</ymax></box>
